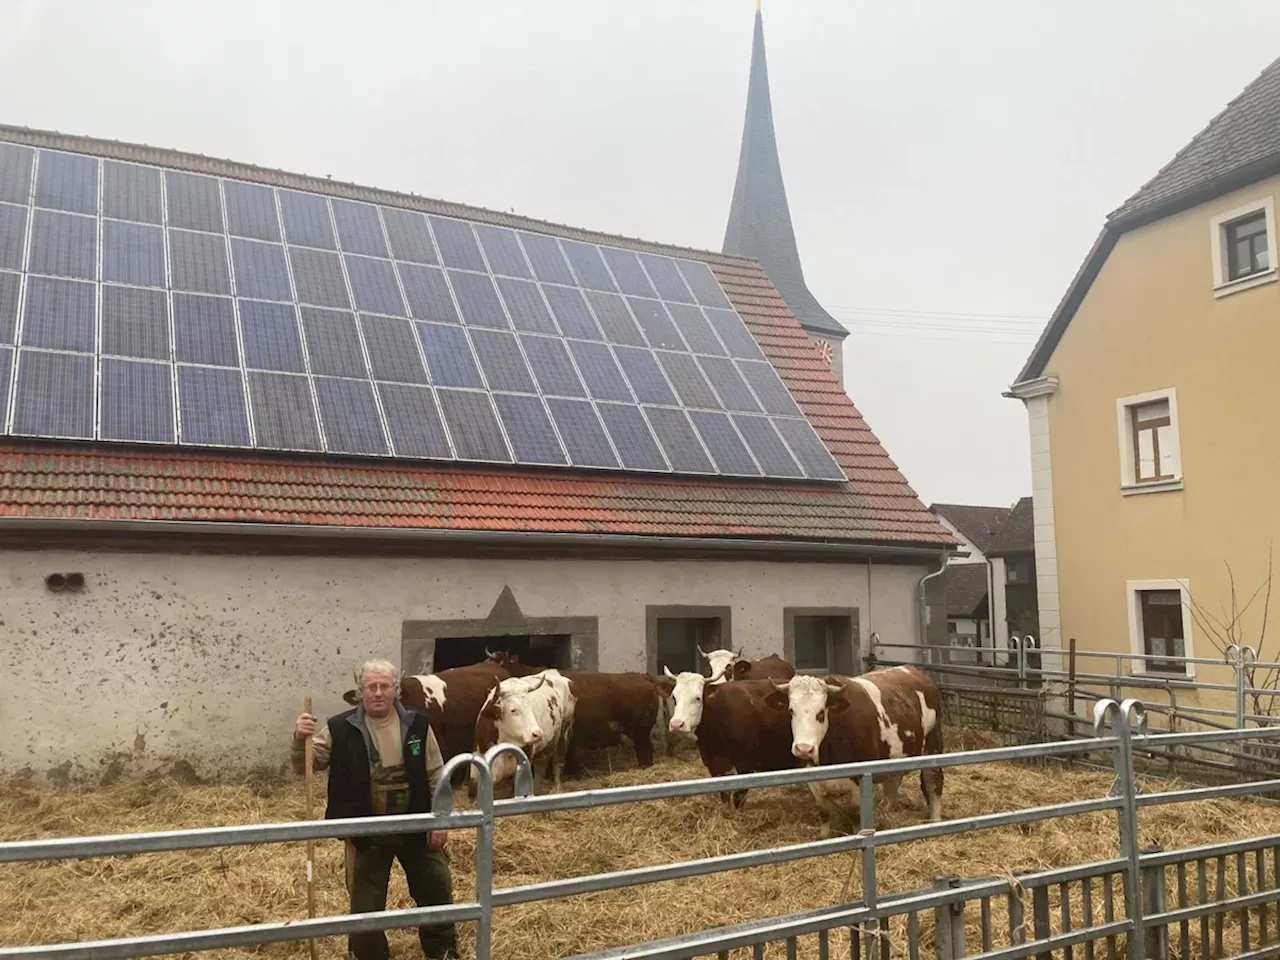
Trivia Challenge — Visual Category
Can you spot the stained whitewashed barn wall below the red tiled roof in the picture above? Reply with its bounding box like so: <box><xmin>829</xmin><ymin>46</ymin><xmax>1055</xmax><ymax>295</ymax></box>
<box><xmin>0</xmin><ymin>550</ymin><xmax>925</xmax><ymax>780</ymax></box>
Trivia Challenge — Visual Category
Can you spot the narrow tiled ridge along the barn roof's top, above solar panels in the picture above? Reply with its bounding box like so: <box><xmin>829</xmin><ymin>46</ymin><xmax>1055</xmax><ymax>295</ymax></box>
<box><xmin>0</xmin><ymin>123</ymin><xmax>759</xmax><ymax>271</ymax></box>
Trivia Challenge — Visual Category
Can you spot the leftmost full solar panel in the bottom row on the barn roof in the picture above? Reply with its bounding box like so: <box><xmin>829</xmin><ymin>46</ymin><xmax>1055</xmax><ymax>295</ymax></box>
<box><xmin>13</xmin><ymin>349</ymin><xmax>93</xmax><ymax>440</ymax></box>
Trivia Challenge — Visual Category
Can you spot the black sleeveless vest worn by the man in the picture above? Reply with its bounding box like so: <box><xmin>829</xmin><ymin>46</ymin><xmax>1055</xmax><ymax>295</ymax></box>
<box><xmin>324</xmin><ymin>708</ymin><xmax>431</xmax><ymax>838</ymax></box>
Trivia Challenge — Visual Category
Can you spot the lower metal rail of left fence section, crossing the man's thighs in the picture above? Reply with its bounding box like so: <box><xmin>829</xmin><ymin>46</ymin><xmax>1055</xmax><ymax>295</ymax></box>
<box><xmin>0</xmin><ymin>902</ymin><xmax>480</xmax><ymax>960</ymax></box>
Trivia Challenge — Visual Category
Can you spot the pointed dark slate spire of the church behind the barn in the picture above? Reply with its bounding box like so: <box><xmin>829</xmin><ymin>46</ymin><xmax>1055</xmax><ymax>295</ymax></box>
<box><xmin>722</xmin><ymin>0</ymin><xmax>849</xmax><ymax>353</ymax></box>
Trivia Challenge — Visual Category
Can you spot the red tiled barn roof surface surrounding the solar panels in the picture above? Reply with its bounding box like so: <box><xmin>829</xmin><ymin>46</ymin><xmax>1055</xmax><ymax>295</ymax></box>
<box><xmin>0</xmin><ymin>127</ymin><xmax>955</xmax><ymax>549</ymax></box>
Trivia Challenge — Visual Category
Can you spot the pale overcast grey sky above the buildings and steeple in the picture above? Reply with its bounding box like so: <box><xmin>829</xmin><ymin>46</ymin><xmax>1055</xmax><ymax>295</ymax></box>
<box><xmin>0</xmin><ymin>0</ymin><xmax>1280</xmax><ymax>504</ymax></box>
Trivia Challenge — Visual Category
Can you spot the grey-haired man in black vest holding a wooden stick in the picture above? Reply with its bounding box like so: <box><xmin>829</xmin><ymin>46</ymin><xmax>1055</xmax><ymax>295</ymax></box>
<box><xmin>291</xmin><ymin>660</ymin><xmax>457</xmax><ymax>960</ymax></box>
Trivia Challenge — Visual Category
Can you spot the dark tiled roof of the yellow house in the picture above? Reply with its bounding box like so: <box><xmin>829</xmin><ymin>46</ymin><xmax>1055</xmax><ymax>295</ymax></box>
<box><xmin>1016</xmin><ymin>59</ymin><xmax>1280</xmax><ymax>383</ymax></box>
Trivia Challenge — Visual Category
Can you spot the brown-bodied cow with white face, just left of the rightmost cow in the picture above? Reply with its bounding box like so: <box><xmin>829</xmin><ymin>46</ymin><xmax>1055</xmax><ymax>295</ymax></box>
<box><xmin>657</xmin><ymin>667</ymin><xmax>797</xmax><ymax>810</ymax></box>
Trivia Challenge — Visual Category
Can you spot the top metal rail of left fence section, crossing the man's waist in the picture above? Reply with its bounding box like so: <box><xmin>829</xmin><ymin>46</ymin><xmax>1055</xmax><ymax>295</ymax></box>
<box><xmin>0</xmin><ymin>810</ymin><xmax>484</xmax><ymax>870</ymax></box>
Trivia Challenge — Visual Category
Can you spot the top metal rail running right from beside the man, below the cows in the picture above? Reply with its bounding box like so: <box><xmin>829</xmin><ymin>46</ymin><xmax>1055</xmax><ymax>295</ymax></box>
<box><xmin>494</xmin><ymin>730</ymin><xmax>1116</xmax><ymax>817</ymax></box>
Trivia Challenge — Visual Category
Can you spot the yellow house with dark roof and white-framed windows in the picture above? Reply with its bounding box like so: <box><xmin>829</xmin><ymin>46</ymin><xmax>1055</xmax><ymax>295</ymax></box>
<box><xmin>1005</xmin><ymin>60</ymin><xmax>1280</xmax><ymax>727</ymax></box>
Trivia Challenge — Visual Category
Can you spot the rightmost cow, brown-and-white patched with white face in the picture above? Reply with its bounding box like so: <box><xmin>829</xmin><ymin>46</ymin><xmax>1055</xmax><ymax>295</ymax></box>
<box><xmin>765</xmin><ymin>664</ymin><xmax>942</xmax><ymax>837</ymax></box>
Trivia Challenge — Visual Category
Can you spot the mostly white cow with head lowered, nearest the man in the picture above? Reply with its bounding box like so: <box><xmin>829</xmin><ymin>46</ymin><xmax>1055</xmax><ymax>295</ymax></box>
<box><xmin>467</xmin><ymin>669</ymin><xmax>577</xmax><ymax>799</ymax></box>
